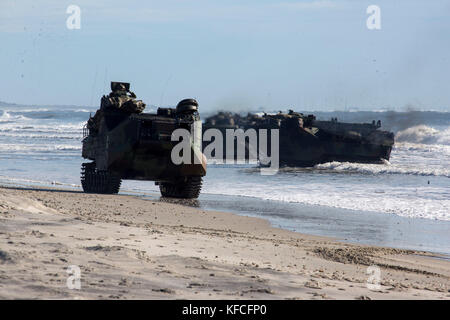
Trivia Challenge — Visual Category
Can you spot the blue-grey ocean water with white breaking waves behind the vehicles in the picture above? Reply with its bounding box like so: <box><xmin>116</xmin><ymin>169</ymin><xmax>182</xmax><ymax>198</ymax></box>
<box><xmin>0</xmin><ymin>105</ymin><xmax>450</xmax><ymax>250</ymax></box>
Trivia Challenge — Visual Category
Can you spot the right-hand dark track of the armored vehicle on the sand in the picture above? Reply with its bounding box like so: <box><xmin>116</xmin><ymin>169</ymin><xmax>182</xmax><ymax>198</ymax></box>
<box><xmin>159</xmin><ymin>177</ymin><xmax>202</xmax><ymax>199</ymax></box>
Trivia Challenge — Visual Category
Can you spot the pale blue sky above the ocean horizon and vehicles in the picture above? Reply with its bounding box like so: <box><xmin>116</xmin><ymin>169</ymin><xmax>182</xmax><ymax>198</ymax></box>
<box><xmin>0</xmin><ymin>0</ymin><xmax>450</xmax><ymax>111</ymax></box>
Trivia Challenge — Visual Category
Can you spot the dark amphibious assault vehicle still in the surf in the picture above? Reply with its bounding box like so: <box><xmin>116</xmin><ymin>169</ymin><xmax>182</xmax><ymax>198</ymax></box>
<box><xmin>203</xmin><ymin>110</ymin><xmax>394</xmax><ymax>167</ymax></box>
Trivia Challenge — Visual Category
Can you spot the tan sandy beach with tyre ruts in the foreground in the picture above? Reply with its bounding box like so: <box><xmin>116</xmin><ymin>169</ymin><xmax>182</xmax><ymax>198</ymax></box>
<box><xmin>0</xmin><ymin>187</ymin><xmax>450</xmax><ymax>299</ymax></box>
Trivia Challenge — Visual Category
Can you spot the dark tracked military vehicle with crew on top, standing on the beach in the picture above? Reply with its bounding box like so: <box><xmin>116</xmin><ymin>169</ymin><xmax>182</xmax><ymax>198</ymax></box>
<box><xmin>81</xmin><ymin>82</ymin><xmax>206</xmax><ymax>198</ymax></box>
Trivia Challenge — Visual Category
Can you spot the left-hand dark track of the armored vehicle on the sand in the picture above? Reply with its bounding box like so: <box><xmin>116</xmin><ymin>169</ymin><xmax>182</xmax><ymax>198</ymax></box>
<box><xmin>81</xmin><ymin>162</ymin><xmax>122</xmax><ymax>194</ymax></box>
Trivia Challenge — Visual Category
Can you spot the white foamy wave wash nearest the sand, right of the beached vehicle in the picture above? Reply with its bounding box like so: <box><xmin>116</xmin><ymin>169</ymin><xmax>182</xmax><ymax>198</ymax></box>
<box><xmin>202</xmin><ymin>181</ymin><xmax>450</xmax><ymax>221</ymax></box>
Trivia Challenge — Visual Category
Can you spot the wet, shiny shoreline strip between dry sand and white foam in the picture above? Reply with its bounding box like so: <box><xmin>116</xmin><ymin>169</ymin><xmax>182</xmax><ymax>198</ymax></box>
<box><xmin>0</xmin><ymin>182</ymin><xmax>450</xmax><ymax>259</ymax></box>
